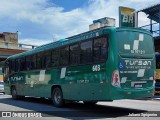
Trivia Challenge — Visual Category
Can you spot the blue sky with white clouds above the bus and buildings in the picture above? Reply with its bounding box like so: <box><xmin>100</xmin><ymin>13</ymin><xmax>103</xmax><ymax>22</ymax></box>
<box><xmin>0</xmin><ymin>0</ymin><xmax>160</xmax><ymax>45</ymax></box>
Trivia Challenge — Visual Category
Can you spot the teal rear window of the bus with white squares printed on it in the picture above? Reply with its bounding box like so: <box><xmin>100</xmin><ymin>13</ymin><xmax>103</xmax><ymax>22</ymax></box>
<box><xmin>117</xmin><ymin>31</ymin><xmax>154</xmax><ymax>55</ymax></box>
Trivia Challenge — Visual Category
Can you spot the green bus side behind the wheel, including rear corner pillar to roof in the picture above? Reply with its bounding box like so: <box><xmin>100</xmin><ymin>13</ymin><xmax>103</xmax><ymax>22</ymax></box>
<box><xmin>63</xmin><ymin>29</ymin><xmax>118</xmax><ymax>101</ymax></box>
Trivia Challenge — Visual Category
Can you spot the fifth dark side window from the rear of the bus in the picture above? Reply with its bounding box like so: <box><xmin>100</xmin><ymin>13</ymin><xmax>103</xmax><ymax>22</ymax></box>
<box><xmin>51</xmin><ymin>49</ymin><xmax>59</xmax><ymax>67</ymax></box>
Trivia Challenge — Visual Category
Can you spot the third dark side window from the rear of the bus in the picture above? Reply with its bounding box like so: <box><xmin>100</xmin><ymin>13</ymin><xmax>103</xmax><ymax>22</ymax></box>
<box><xmin>69</xmin><ymin>43</ymin><xmax>80</xmax><ymax>65</ymax></box>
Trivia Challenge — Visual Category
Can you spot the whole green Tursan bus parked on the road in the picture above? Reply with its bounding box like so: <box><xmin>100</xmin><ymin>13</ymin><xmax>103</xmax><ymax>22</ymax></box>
<box><xmin>3</xmin><ymin>27</ymin><xmax>155</xmax><ymax>107</ymax></box>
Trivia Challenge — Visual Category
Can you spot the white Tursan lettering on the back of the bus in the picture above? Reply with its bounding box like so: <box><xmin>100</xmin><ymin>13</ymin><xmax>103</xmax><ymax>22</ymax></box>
<box><xmin>125</xmin><ymin>60</ymin><xmax>152</xmax><ymax>66</ymax></box>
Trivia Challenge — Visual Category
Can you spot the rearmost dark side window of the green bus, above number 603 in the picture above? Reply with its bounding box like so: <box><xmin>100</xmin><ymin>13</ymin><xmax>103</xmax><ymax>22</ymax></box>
<box><xmin>93</xmin><ymin>37</ymin><xmax>108</xmax><ymax>62</ymax></box>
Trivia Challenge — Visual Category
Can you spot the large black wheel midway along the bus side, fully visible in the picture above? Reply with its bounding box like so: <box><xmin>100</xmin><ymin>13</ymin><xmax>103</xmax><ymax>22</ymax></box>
<box><xmin>52</xmin><ymin>87</ymin><xmax>64</xmax><ymax>107</ymax></box>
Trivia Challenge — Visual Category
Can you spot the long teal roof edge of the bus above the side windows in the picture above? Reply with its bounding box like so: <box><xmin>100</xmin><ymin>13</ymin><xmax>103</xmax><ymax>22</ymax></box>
<box><xmin>7</xmin><ymin>27</ymin><xmax>151</xmax><ymax>60</ymax></box>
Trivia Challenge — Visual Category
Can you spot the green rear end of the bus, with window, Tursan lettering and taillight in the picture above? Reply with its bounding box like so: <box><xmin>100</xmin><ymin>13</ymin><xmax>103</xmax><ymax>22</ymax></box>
<box><xmin>112</xmin><ymin>29</ymin><xmax>155</xmax><ymax>99</ymax></box>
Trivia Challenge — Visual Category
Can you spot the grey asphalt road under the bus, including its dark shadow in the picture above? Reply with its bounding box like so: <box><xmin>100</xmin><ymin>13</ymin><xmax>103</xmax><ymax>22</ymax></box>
<box><xmin>0</xmin><ymin>94</ymin><xmax>160</xmax><ymax>120</ymax></box>
